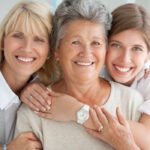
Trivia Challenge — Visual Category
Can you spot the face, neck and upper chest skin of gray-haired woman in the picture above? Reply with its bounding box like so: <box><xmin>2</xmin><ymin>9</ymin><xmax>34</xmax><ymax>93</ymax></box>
<box><xmin>53</xmin><ymin>20</ymin><xmax>110</xmax><ymax>106</ymax></box>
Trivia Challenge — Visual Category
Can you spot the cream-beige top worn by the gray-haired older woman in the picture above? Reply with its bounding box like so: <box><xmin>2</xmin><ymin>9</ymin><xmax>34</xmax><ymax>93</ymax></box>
<box><xmin>15</xmin><ymin>82</ymin><xmax>143</xmax><ymax>150</ymax></box>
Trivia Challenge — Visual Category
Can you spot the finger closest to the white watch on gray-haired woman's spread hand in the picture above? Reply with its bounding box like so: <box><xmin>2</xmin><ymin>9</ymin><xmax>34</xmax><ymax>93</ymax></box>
<box><xmin>90</xmin><ymin>108</ymin><xmax>101</xmax><ymax>129</ymax></box>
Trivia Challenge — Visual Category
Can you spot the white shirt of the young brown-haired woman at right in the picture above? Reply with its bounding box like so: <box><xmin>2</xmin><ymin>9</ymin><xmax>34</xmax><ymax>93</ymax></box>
<box><xmin>100</xmin><ymin>62</ymin><xmax>150</xmax><ymax>115</ymax></box>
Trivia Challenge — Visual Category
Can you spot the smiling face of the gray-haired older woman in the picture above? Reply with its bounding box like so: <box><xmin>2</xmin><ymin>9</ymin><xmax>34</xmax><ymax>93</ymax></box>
<box><xmin>55</xmin><ymin>20</ymin><xmax>106</xmax><ymax>81</ymax></box>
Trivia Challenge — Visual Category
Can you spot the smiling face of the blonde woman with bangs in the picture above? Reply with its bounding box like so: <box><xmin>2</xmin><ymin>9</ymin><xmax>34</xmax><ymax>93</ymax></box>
<box><xmin>3</xmin><ymin>24</ymin><xmax>49</xmax><ymax>76</ymax></box>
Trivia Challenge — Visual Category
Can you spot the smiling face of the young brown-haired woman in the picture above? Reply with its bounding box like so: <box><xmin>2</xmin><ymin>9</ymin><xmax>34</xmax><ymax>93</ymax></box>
<box><xmin>106</xmin><ymin>30</ymin><xmax>148</xmax><ymax>85</ymax></box>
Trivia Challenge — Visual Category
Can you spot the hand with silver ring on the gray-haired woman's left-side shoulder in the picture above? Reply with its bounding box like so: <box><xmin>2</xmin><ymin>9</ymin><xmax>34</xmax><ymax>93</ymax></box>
<box><xmin>20</xmin><ymin>82</ymin><xmax>51</xmax><ymax>112</ymax></box>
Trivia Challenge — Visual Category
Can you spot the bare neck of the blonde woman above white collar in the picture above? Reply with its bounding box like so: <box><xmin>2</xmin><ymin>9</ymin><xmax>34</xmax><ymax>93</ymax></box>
<box><xmin>1</xmin><ymin>67</ymin><xmax>30</xmax><ymax>94</ymax></box>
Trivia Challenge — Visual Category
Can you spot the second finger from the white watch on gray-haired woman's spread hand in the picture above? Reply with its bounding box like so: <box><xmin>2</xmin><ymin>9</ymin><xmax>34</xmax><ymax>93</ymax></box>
<box><xmin>94</xmin><ymin>107</ymin><xmax>108</xmax><ymax>126</ymax></box>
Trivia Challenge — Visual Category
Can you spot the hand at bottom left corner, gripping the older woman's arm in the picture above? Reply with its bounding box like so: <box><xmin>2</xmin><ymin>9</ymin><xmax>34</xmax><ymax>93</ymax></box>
<box><xmin>8</xmin><ymin>132</ymin><xmax>42</xmax><ymax>150</ymax></box>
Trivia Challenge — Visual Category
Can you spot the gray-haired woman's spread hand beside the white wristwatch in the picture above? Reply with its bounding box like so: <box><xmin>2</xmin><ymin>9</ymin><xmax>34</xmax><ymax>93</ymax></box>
<box><xmin>87</xmin><ymin>107</ymin><xmax>139</xmax><ymax>150</ymax></box>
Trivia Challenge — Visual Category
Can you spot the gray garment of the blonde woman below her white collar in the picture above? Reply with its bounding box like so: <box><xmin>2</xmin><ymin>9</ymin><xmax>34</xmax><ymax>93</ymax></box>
<box><xmin>0</xmin><ymin>103</ymin><xmax>20</xmax><ymax>146</ymax></box>
